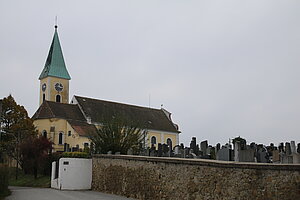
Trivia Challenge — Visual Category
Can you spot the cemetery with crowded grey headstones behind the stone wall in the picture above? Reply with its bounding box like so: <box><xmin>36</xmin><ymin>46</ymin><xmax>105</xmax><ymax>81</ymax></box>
<box><xmin>139</xmin><ymin>137</ymin><xmax>300</xmax><ymax>164</ymax></box>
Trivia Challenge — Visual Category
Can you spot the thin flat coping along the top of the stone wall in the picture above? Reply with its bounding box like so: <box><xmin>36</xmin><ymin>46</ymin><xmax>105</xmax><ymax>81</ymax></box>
<box><xmin>92</xmin><ymin>154</ymin><xmax>300</xmax><ymax>172</ymax></box>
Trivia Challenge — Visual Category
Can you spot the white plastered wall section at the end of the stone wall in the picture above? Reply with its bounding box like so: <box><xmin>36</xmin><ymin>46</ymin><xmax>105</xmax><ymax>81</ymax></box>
<box><xmin>51</xmin><ymin>158</ymin><xmax>92</xmax><ymax>190</ymax></box>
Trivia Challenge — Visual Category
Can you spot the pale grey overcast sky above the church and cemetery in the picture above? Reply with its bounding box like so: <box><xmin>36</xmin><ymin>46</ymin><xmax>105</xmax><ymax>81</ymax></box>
<box><xmin>0</xmin><ymin>0</ymin><xmax>300</xmax><ymax>145</ymax></box>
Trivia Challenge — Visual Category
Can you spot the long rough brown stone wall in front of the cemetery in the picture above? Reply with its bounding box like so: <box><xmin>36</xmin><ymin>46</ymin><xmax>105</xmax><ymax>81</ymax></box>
<box><xmin>92</xmin><ymin>155</ymin><xmax>300</xmax><ymax>200</ymax></box>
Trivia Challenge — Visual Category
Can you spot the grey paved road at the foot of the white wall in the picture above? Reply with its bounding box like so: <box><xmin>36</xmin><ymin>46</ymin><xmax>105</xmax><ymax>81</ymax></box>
<box><xmin>5</xmin><ymin>187</ymin><xmax>132</xmax><ymax>200</ymax></box>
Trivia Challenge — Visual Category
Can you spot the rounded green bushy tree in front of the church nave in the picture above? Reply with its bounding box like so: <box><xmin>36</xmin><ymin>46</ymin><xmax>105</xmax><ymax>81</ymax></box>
<box><xmin>89</xmin><ymin>117</ymin><xmax>143</xmax><ymax>154</ymax></box>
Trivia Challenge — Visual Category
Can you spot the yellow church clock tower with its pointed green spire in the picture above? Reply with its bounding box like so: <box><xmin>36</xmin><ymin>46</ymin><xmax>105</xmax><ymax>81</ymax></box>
<box><xmin>39</xmin><ymin>25</ymin><xmax>71</xmax><ymax>105</ymax></box>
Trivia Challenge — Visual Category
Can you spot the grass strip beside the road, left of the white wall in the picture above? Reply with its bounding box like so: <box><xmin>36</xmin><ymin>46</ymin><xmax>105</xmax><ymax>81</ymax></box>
<box><xmin>8</xmin><ymin>169</ymin><xmax>51</xmax><ymax>188</ymax></box>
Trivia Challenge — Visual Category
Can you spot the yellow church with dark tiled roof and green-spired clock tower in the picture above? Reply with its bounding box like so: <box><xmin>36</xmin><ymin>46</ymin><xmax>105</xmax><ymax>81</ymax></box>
<box><xmin>32</xmin><ymin>26</ymin><xmax>180</xmax><ymax>152</ymax></box>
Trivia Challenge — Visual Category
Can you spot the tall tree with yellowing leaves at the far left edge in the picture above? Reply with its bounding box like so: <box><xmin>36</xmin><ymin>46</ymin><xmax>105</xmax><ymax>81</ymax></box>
<box><xmin>0</xmin><ymin>95</ymin><xmax>37</xmax><ymax>179</ymax></box>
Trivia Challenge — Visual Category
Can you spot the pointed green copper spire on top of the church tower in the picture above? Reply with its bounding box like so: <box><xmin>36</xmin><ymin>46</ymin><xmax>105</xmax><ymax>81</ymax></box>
<box><xmin>39</xmin><ymin>26</ymin><xmax>71</xmax><ymax>80</ymax></box>
